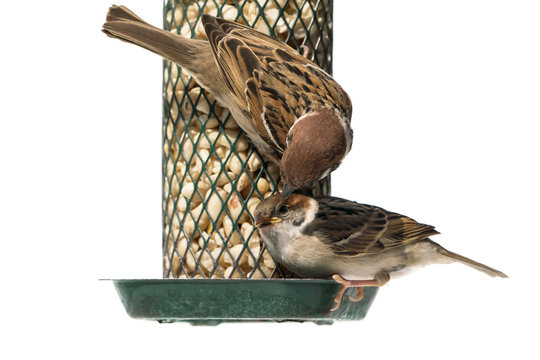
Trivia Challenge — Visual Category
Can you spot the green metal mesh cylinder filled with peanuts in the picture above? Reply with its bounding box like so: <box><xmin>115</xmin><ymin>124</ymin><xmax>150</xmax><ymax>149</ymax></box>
<box><xmin>163</xmin><ymin>0</ymin><xmax>332</xmax><ymax>278</ymax></box>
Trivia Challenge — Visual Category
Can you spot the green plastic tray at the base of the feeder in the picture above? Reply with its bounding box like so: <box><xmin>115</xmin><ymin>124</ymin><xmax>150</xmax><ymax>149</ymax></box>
<box><xmin>112</xmin><ymin>279</ymin><xmax>378</xmax><ymax>325</ymax></box>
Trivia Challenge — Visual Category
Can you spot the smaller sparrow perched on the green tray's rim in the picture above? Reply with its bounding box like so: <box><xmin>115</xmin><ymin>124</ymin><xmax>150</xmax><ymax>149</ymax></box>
<box><xmin>255</xmin><ymin>194</ymin><xmax>507</xmax><ymax>310</ymax></box>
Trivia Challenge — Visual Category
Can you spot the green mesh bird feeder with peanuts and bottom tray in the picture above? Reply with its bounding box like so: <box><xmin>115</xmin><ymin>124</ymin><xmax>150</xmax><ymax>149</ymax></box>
<box><xmin>115</xmin><ymin>0</ymin><xmax>377</xmax><ymax>324</ymax></box>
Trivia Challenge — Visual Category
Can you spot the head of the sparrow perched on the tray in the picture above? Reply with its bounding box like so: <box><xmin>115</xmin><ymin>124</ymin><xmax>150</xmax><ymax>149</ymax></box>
<box><xmin>255</xmin><ymin>194</ymin><xmax>318</xmax><ymax>231</ymax></box>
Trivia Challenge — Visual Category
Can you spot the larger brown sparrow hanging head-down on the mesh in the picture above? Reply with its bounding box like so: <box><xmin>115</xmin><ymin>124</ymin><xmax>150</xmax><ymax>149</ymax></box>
<box><xmin>102</xmin><ymin>6</ymin><xmax>352</xmax><ymax>196</ymax></box>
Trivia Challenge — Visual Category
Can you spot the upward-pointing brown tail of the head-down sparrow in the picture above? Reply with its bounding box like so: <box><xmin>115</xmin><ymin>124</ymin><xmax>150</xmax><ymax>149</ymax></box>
<box><xmin>102</xmin><ymin>5</ymin><xmax>225</xmax><ymax>95</ymax></box>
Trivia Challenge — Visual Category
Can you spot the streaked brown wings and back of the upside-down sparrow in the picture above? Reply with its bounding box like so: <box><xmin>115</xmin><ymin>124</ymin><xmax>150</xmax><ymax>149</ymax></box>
<box><xmin>202</xmin><ymin>15</ymin><xmax>352</xmax><ymax>153</ymax></box>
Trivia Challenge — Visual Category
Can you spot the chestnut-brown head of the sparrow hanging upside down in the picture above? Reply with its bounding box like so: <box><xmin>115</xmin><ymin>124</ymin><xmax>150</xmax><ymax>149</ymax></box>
<box><xmin>279</xmin><ymin>110</ymin><xmax>352</xmax><ymax>198</ymax></box>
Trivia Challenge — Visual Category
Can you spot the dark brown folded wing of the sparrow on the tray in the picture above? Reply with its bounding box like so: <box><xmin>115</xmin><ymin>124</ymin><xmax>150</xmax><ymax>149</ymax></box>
<box><xmin>305</xmin><ymin>197</ymin><xmax>439</xmax><ymax>256</ymax></box>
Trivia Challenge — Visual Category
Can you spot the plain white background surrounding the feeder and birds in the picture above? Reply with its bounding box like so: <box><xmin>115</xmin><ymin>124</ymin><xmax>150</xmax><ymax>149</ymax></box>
<box><xmin>0</xmin><ymin>0</ymin><xmax>540</xmax><ymax>359</ymax></box>
